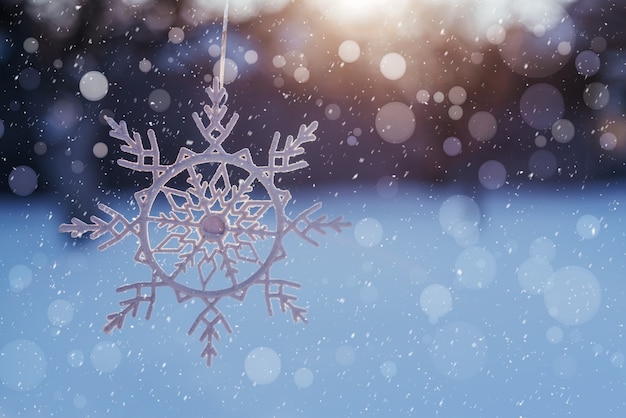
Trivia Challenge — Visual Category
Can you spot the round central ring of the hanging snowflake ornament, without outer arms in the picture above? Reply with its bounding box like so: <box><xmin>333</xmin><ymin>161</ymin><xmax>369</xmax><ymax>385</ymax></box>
<box><xmin>139</xmin><ymin>152</ymin><xmax>290</xmax><ymax>298</ymax></box>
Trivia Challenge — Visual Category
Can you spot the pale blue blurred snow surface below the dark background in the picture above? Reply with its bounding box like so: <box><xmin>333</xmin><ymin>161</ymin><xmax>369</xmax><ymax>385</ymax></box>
<box><xmin>0</xmin><ymin>182</ymin><xmax>626</xmax><ymax>418</ymax></box>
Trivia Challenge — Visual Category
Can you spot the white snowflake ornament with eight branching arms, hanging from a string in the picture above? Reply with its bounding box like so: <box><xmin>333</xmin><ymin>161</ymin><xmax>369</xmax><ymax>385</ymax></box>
<box><xmin>59</xmin><ymin>77</ymin><xmax>350</xmax><ymax>366</ymax></box>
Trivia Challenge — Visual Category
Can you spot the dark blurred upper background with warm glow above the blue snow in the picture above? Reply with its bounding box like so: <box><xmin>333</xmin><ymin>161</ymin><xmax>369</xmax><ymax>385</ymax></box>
<box><xmin>0</xmin><ymin>0</ymin><xmax>626</xmax><ymax>212</ymax></box>
